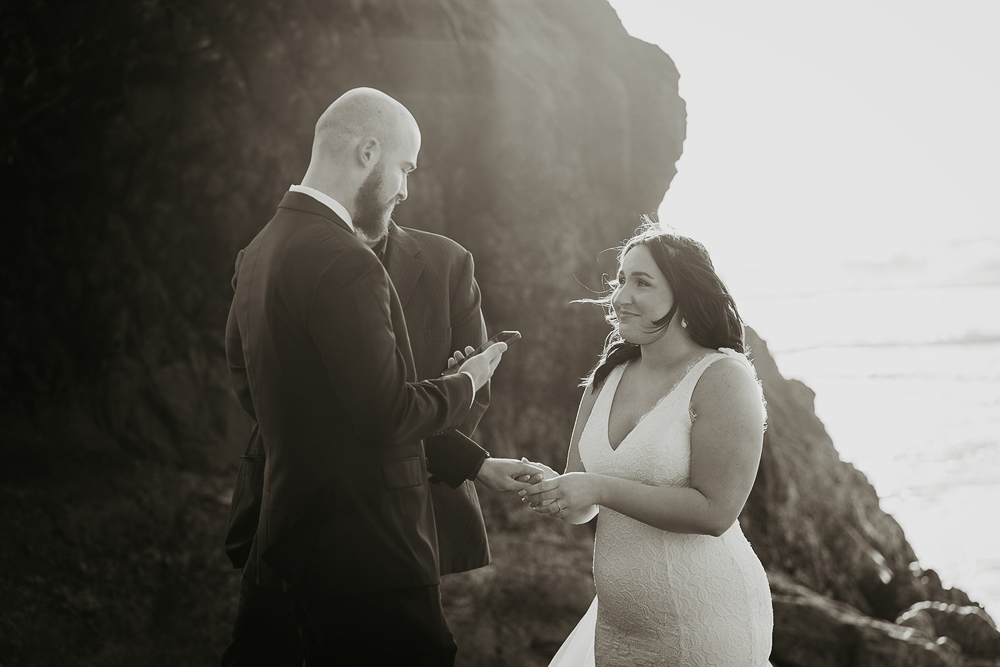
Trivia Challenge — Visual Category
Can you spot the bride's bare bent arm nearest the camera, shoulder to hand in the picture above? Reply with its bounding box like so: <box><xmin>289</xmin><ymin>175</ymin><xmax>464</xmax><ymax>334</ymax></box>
<box><xmin>523</xmin><ymin>359</ymin><xmax>764</xmax><ymax>535</ymax></box>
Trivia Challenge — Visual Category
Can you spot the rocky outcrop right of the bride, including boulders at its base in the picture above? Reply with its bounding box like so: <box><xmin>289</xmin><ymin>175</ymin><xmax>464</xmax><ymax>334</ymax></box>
<box><xmin>740</xmin><ymin>330</ymin><xmax>1000</xmax><ymax>667</ymax></box>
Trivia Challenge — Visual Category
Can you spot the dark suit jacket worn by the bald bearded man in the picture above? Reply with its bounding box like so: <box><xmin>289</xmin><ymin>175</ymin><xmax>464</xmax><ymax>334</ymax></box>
<box><xmin>226</xmin><ymin>192</ymin><xmax>492</xmax><ymax>596</ymax></box>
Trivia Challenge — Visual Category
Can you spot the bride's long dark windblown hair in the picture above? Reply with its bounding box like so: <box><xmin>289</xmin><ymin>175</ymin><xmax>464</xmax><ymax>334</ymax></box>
<box><xmin>581</xmin><ymin>222</ymin><xmax>746</xmax><ymax>389</ymax></box>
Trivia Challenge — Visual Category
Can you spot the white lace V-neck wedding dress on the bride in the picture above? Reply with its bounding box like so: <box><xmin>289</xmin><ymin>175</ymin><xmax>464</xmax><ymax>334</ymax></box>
<box><xmin>550</xmin><ymin>350</ymin><xmax>772</xmax><ymax>667</ymax></box>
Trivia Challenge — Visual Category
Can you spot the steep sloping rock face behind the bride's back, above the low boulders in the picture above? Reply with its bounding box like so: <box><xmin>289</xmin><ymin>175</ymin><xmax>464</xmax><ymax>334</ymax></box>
<box><xmin>740</xmin><ymin>331</ymin><xmax>969</xmax><ymax>621</ymax></box>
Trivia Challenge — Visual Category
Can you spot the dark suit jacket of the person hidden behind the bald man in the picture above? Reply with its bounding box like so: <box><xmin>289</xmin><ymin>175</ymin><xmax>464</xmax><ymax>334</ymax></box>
<box><xmin>226</xmin><ymin>224</ymin><xmax>490</xmax><ymax>574</ymax></box>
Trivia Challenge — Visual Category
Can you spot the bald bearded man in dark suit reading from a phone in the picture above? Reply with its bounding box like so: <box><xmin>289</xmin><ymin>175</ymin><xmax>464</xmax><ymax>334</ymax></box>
<box><xmin>226</xmin><ymin>88</ymin><xmax>541</xmax><ymax>666</ymax></box>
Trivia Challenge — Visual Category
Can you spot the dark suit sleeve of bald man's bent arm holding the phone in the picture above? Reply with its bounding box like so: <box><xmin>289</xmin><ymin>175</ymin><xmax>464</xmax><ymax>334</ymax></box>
<box><xmin>307</xmin><ymin>249</ymin><xmax>473</xmax><ymax>444</ymax></box>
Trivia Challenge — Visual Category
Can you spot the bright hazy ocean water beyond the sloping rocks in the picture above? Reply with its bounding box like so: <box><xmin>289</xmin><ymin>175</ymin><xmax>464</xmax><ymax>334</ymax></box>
<box><xmin>740</xmin><ymin>285</ymin><xmax>1000</xmax><ymax>619</ymax></box>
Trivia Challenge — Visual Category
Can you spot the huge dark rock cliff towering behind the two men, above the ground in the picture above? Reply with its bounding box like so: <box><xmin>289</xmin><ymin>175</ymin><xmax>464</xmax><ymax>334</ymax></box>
<box><xmin>0</xmin><ymin>0</ymin><xmax>685</xmax><ymax>474</ymax></box>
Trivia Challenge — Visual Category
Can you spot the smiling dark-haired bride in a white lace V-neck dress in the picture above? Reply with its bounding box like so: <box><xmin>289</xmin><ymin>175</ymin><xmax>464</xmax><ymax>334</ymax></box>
<box><xmin>520</xmin><ymin>226</ymin><xmax>772</xmax><ymax>667</ymax></box>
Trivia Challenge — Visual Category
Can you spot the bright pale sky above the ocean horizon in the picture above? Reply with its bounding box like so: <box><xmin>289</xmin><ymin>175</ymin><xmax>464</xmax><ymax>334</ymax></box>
<box><xmin>611</xmin><ymin>0</ymin><xmax>1000</xmax><ymax>306</ymax></box>
